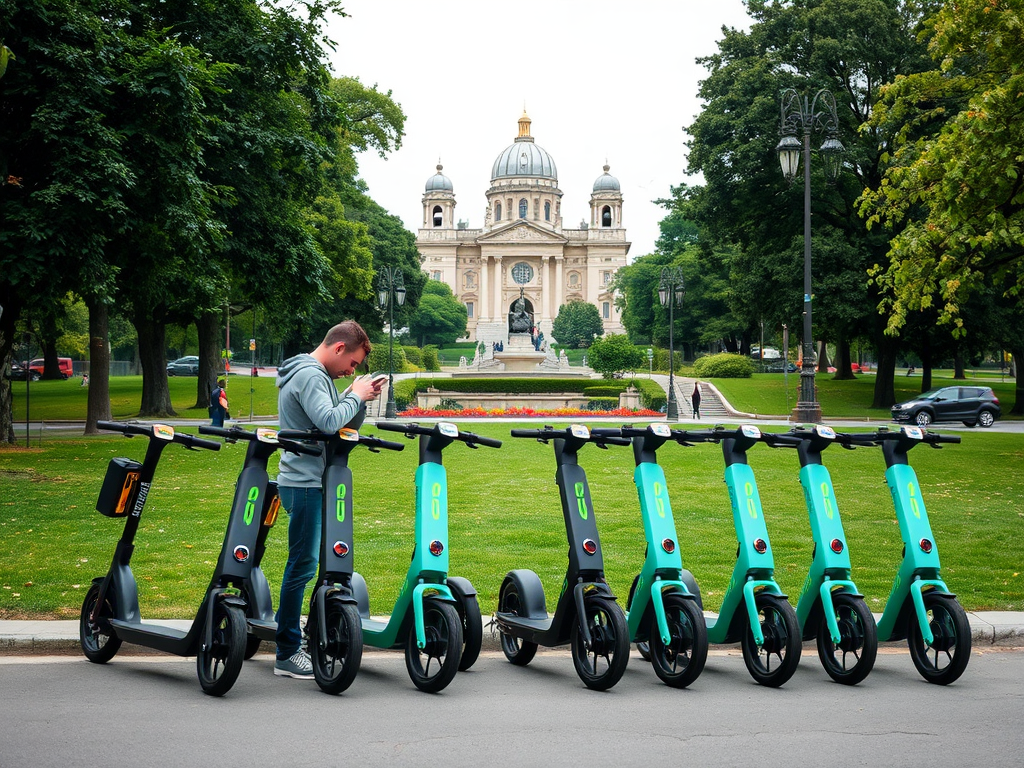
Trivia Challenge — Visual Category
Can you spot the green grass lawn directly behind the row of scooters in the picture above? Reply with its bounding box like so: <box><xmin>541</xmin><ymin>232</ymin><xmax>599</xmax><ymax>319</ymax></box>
<box><xmin>0</xmin><ymin>423</ymin><xmax>1024</xmax><ymax>618</ymax></box>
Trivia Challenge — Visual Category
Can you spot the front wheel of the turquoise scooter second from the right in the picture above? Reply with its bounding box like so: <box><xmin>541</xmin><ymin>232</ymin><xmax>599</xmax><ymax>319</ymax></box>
<box><xmin>817</xmin><ymin>592</ymin><xmax>879</xmax><ymax>685</ymax></box>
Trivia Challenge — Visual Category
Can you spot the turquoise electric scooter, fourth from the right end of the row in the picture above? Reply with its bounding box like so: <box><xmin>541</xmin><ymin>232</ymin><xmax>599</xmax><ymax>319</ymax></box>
<box><xmin>592</xmin><ymin>423</ymin><xmax>708</xmax><ymax>688</ymax></box>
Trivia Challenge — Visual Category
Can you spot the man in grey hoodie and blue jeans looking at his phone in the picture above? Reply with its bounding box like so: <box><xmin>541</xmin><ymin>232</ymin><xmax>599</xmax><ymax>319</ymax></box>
<box><xmin>273</xmin><ymin>321</ymin><xmax>383</xmax><ymax>679</ymax></box>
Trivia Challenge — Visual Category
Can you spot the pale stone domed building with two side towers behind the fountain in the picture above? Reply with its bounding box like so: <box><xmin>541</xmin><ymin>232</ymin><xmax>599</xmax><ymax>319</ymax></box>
<box><xmin>416</xmin><ymin>111</ymin><xmax>630</xmax><ymax>342</ymax></box>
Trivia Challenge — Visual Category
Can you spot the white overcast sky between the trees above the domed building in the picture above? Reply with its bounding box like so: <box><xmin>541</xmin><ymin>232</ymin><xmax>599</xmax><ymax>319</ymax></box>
<box><xmin>329</xmin><ymin>0</ymin><xmax>749</xmax><ymax>260</ymax></box>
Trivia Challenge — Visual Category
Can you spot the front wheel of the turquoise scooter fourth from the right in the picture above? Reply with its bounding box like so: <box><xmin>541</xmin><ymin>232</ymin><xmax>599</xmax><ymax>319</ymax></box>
<box><xmin>650</xmin><ymin>593</ymin><xmax>708</xmax><ymax>688</ymax></box>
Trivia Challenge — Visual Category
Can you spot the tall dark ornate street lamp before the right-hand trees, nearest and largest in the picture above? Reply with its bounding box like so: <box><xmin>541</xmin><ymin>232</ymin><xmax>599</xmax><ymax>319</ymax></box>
<box><xmin>775</xmin><ymin>88</ymin><xmax>844</xmax><ymax>422</ymax></box>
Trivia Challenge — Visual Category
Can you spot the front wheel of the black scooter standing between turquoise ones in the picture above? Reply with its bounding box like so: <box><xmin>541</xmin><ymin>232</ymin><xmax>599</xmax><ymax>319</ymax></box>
<box><xmin>572</xmin><ymin>597</ymin><xmax>630</xmax><ymax>690</ymax></box>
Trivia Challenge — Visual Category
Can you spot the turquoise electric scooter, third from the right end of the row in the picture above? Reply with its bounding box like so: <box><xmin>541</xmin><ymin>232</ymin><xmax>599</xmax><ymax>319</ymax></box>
<box><xmin>677</xmin><ymin>425</ymin><xmax>801</xmax><ymax>688</ymax></box>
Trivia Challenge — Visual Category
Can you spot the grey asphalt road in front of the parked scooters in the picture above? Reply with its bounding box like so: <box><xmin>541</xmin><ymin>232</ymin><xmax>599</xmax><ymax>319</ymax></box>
<box><xmin>0</xmin><ymin>646</ymin><xmax>1024</xmax><ymax>768</ymax></box>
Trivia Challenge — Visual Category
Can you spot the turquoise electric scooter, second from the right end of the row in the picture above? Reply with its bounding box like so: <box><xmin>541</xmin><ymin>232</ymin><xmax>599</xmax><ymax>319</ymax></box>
<box><xmin>763</xmin><ymin>425</ymin><xmax>879</xmax><ymax>685</ymax></box>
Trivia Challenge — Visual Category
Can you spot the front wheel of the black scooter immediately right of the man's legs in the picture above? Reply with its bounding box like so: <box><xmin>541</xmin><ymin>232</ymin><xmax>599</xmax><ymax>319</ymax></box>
<box><xmin>306</xmin><ymin>597</ymin><xmax>362</xmax><ymax>694</ymax></box>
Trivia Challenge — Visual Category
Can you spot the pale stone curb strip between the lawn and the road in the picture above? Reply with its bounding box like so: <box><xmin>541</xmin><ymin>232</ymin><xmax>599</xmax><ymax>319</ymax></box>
<box><xmin>0</xmin><ymin>610</ymin><xmax>1024</xmax><ymax>656</ymax></box>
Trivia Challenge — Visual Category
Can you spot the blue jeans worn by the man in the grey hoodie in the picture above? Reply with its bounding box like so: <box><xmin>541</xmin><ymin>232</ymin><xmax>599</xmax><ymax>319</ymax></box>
<box><xmin>278</xmin><ymin>486</ymin><xmax>324</xmax><ymax>660</ymax></box>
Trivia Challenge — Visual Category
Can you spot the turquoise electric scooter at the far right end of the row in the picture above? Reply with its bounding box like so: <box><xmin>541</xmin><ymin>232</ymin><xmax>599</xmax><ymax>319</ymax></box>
<box><xmin>844</xmin><ymin>426</ymin><xmax>971</xmax><ymax>685</ymax></box>
